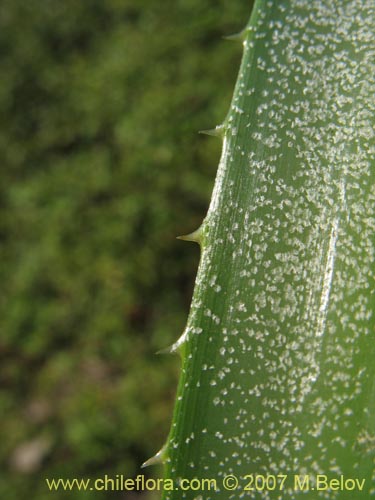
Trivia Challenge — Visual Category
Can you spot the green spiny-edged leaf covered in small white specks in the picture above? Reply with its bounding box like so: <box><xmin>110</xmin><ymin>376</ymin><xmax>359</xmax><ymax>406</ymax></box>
<box><xmin>163</xmin><ymin>0</ymin><xmax>375</xmax><ymax>500</ymax></box>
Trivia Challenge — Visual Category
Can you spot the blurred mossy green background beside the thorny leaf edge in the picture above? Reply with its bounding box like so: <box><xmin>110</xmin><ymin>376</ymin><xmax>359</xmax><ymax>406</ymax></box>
<box><xmin>0</xmin><ymin>0</ymin><xmax>251</xmax><ymax>500</ymax></box>
